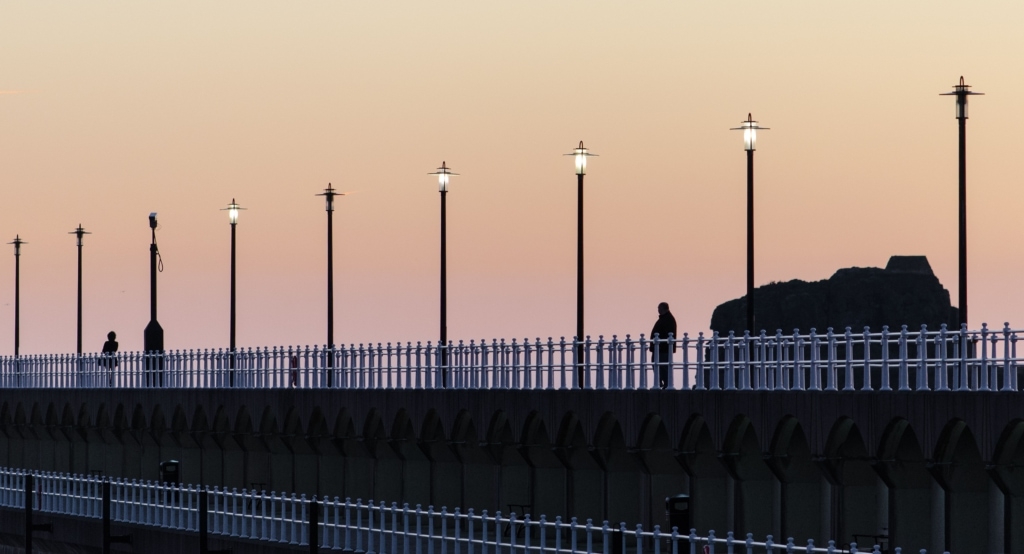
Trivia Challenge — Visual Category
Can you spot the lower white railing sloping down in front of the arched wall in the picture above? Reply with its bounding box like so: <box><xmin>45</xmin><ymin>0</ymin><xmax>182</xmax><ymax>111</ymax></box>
<box><xmin>0</xmin><ymin>468</ymin><xmax>948</xmax><ymax>554</ymax></box>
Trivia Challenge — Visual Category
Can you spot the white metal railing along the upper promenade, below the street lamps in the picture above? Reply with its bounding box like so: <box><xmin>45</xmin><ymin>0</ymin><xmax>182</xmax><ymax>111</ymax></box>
<box><xmin>0</xmin><ymin>324</ymin><xmax>1024</xmax><ymax>391</ymax></box>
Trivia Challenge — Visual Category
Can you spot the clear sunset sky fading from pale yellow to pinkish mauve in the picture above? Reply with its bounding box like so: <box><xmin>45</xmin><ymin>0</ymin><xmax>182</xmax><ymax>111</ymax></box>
<box><xmin>0</xmin><ymin>0</ymin><xmax>1024</xmax><ymax>354</ymax></box>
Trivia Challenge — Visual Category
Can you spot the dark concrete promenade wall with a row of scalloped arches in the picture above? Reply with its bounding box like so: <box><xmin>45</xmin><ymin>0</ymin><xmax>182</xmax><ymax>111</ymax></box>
<box><xmin>0</xmin><ymin>389</ymin><xmax>1024</xmax><ymax>552</ymax></box>
